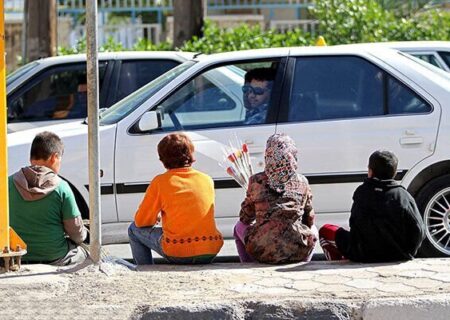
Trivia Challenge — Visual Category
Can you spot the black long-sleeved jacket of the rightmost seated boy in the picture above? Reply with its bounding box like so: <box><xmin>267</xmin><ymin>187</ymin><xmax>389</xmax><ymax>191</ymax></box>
<box><xmin>336</xmin><ymin>178</ymin><xmax>425</xmax><ymax>262</ymax></box>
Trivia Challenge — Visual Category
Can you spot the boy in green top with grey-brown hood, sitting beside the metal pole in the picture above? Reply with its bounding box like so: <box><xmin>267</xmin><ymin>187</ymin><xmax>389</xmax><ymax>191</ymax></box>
<box><xmin>8</xmin><ymin>132</ymin><xmax>87</xmax><ymax>266</ymax></box>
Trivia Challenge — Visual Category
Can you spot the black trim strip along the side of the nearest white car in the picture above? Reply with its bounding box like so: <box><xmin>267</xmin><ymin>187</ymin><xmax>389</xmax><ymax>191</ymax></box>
<box><xmin>91</xmin><ymin>170</ymin><xmax>408</xmax><ymax>195</ymax></box>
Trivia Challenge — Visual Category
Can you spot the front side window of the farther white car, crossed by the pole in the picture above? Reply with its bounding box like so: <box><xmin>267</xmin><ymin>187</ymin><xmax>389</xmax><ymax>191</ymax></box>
<box><xmin>8</xmin><ymin>62</ymin><xmax>106</xmax><ymax>122</ymax></box>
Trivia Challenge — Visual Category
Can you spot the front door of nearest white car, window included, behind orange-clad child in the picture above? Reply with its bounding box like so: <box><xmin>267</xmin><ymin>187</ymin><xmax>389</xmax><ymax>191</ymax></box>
<box><xmin>116</xmin><ymin>59</ymin><xmax>284</xmax><ymax>236</ymax></box>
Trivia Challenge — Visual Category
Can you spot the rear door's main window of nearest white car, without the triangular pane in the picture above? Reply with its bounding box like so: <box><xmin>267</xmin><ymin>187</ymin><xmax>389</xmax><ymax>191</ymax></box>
<box><xmin>288</xmin><ymin>57</ymin><xmax>383</xmax><ymax>121</ymax></box>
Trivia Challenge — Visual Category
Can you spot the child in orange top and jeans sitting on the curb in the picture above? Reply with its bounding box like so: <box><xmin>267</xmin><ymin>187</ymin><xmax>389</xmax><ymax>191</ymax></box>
<box><xmin>128</xmin><ymin>133</ymin><xmax>223</xmax><ymax>265</ymax></box>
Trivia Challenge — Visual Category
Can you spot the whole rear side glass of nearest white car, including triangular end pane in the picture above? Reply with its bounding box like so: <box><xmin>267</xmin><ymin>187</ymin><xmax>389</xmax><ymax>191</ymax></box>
<box><xmin>288</xmin><ymin>56</ymin><xmax>431</xmax><ymax>122</ymax></box>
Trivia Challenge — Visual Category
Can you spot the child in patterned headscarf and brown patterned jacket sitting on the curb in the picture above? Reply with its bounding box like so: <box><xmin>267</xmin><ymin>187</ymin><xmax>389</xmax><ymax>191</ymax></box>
<box><xmin>234</xmin><ymin>134</ymin><xmax>317</xmax><ymax>263</ymax></box>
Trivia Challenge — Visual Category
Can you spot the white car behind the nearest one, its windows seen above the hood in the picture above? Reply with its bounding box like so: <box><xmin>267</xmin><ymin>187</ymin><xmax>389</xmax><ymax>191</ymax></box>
<box><xmin>6</xmin><ymin>51</ymin><xmax>193</xmax><ymax>132</ymax></box>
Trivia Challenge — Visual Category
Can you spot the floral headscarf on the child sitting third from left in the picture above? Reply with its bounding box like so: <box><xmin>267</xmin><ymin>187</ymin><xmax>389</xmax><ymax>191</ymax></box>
<box><xmin>264</xmin><ymin>133</ymin><xmax>298</xmax><ymax>193</ymax></box>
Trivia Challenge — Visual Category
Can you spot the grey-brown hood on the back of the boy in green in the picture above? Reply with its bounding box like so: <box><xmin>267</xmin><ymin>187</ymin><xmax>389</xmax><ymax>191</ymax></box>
<box><xmin>13</xmin><ymin>166</ymin><xmax>61</xmax><ymax>201</ymax></box>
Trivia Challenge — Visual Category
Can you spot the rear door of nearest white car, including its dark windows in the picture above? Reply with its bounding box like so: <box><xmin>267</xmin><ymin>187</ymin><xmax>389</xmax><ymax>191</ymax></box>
<box><xmin>277</xmin><ymin>56</ymin><xmax>440</xmax><ymax>225</ymax></box>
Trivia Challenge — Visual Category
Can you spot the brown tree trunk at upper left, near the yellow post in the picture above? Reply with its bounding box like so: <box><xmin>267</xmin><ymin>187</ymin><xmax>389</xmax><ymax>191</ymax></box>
<box><xmin>23</xmin><ymin>0</ymin><xmax>57</xmax><ymax>62</ymax></box>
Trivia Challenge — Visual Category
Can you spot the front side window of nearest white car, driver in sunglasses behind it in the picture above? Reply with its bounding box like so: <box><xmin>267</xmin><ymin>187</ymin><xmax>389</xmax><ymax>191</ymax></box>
<box><xmin>159</xmin><ymin>61</ymin><xmax>279</xmax><ymax>131</ymax></box>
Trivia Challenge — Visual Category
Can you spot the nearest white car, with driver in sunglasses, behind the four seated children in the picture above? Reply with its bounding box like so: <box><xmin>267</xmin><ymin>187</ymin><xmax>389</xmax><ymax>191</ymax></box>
<box><xmin>8</xmin><ymin>45</ymin><xmax>450</xmax><ymax>255</ymax></box>
